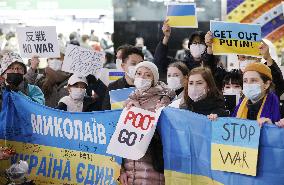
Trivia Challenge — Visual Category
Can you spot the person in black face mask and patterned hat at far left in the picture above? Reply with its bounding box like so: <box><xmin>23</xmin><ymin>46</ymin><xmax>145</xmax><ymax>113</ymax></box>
<box><xmin>0</xmin><ymin>52</ymin><xmax>45</xmax><ymax>110</ymax></box>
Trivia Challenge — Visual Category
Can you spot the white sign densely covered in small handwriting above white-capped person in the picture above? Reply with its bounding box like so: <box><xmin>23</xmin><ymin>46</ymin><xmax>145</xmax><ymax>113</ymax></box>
<box><xmin>62</xmin><ymin>44</ymin><xmax>105</xmax><ymax>77</ymax></box>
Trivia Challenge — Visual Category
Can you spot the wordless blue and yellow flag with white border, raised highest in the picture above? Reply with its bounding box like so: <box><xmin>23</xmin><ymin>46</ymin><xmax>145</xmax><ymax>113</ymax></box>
<box><xmin>167</xmin><ymin>3</ymin><xmax>198</xmax><ymax>28</ymax></box>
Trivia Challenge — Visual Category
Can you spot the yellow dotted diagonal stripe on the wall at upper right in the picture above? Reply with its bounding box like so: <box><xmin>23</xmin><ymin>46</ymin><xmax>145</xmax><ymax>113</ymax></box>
<box><xmin>227</xmin><ymin>0</ymin><xmax>269</xmax><ymax>22</ymax></box>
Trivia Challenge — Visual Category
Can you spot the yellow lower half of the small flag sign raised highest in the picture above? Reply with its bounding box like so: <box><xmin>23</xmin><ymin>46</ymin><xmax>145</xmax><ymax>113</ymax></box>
<box><xmin>167</xmin><ymin>16</ymin><xmax>197</xmax><ymax>27</ymax></box>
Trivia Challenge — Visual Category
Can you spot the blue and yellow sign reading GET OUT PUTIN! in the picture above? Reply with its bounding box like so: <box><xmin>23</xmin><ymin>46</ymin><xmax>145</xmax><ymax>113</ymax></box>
<box><xmin>210</xmin><ymin>21</ymin><xmax>261</xmax><ymax>57</ymax></box>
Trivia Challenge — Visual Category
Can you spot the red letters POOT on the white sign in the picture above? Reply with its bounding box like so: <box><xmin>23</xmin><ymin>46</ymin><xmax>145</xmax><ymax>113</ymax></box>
<box><xmin>124</xmin><ymin>111</ymin><xmax>155</xmax><ymax>130</ymax></box>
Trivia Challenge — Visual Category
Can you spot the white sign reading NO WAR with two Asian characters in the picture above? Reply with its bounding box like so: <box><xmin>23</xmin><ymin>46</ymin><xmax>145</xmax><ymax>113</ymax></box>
<box><xmin>16</xmin><ymin>26</ymin><xmax>60</xmax><ymax>58</ymax></box>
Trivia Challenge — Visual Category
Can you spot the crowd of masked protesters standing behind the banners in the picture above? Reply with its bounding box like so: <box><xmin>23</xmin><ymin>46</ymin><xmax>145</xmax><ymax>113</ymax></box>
<box><xmin>0</xmin><ymin>21</ymin><xmax>284</xmax><ymax>184</ymax></box>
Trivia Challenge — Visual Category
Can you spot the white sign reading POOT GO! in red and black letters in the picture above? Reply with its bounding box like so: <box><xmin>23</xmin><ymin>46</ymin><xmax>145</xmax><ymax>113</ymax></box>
<box><xmin>107</xmin><ymin>107</ymin><xmax>162</xmax><ymax>160</ymax></box>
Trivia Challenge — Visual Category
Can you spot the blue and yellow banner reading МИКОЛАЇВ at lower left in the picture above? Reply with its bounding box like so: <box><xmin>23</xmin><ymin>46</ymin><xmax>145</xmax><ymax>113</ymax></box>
<box><xmin>0</xmin><ymin>92</ymin><xmax>121</xmax><ymax>185</ymax></box>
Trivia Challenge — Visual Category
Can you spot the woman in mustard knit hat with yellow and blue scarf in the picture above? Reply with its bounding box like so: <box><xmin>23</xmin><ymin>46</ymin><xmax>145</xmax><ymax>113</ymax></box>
<box><xmin>232</xmin><ymin>62</ymin><xmax>280</xmax><ymax>126</ymax></box>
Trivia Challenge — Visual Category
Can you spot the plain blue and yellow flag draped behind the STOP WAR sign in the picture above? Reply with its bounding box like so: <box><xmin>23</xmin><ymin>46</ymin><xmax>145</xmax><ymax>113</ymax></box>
<box><xmin>158</xmin><ymin>108</ymin><xmax>284</xmax><ymax>185</ymax></box>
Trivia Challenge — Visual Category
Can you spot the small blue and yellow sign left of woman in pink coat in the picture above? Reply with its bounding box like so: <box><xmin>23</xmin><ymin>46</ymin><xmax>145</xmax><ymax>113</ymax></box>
<box><xmin>109</xmin><ymin>87</ymin><xmax>135</xmax><ymax>110</ymax></box>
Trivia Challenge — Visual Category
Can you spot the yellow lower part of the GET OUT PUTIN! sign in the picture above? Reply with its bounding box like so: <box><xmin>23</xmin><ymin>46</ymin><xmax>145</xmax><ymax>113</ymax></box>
<box><xmin>213</xmin><ymin>38</ymin><xmax>261</xmax><ymax>56</ymax></box>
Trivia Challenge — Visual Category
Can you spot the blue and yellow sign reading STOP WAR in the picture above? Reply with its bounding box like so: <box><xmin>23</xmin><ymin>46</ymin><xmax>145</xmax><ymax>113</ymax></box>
<box><xmin>211</xmin><ymin>118</ymin><xmax>260</xmax><ymax>176</ymax></box>
